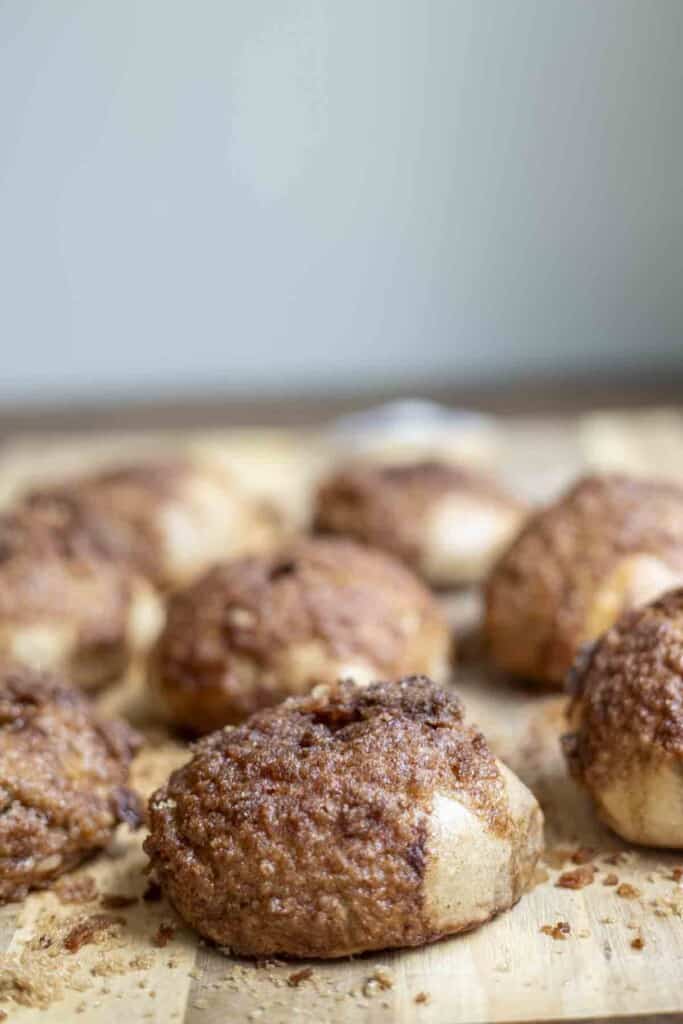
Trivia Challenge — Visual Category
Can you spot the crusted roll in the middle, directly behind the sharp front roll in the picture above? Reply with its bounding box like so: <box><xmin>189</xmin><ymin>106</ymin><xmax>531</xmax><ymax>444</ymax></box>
<box><xmin>150</xmin><ymin>539</ymin><xmax>452</xmax><ymax>732</ymax></box>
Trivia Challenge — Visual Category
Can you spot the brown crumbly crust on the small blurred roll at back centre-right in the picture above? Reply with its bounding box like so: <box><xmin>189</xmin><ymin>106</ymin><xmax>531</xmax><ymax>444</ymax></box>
<box><xmin>313</xmin><ymin>461</ymin><xmax>523</xmax><ymax>568</ymax></box>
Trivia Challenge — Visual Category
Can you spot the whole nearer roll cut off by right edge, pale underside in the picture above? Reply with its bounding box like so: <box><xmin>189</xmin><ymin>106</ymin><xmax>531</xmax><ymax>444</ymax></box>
<box><xmin>563</xmin><ymin>590</ymin><xmax>683</xmax><ymax>849</ymax></box>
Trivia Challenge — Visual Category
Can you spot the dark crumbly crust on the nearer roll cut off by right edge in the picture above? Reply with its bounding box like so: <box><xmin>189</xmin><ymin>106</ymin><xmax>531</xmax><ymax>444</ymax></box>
<box><xmin>563</xmin><ymin>589</ymin><xmax>683</xmax><ymax>790</ymax></box>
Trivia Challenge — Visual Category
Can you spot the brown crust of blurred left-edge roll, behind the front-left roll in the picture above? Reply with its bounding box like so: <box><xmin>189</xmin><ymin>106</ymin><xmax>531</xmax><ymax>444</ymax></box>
<box><xmin>0</xmin><ymin>504</ymin><xmax>132</xmax><ymax>650</ymax></box>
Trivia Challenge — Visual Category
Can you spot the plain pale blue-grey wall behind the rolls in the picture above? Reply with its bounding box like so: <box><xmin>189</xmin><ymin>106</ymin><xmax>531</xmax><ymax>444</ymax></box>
<box><xmin>0</xmin><ymin>0</ymin><xmax>683</xmax><ymax>400</ymax></box>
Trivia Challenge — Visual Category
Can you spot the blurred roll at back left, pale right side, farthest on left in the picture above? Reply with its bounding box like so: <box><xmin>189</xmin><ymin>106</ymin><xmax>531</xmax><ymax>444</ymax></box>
<box><xmin>30</xmin><ymin>457</ymin><xmax>280</xmax><ymax>590</ymax></box>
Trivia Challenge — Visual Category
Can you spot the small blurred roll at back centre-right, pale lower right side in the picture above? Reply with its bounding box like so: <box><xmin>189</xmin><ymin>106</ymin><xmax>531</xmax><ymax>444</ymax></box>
<box><xmin>313</xmin><ymin>462</ymin><xmax>526</xmax><ymax>587</ymax></box>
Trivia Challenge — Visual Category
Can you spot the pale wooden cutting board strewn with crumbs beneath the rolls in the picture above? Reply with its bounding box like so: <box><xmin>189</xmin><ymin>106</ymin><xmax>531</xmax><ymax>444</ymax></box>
<box><xmin>0</xmin><ymin>414</ymin><xmax>683</xmax><ymax>1024</ymax></box>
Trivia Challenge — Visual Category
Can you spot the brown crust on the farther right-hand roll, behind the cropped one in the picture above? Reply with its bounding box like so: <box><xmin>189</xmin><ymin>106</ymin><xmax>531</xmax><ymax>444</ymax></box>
<box><xmin>486</xmin><ymin>476</ymin><xmax>683</xmax><ymax>686</ymax></box>
